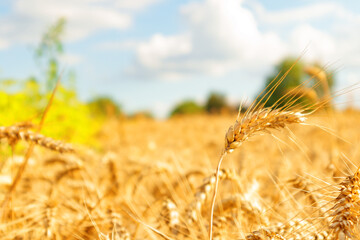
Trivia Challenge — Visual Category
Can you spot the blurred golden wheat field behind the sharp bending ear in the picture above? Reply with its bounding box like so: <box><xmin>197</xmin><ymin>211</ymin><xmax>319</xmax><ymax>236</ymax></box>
<box><xmin>0</xmin><ymin>111</ymin><xmax>360</xmax><ymax>239</ymax></box>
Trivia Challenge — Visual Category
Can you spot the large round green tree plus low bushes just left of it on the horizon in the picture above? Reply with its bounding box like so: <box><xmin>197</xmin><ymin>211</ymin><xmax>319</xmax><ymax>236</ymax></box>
<box><xmin>170</xmin><ymin>57</ymin><xmax>335</xmax><ymax>116</ymax></box>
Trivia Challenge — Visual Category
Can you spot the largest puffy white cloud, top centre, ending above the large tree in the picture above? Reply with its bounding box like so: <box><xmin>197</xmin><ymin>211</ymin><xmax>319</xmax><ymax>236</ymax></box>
<box><xmin>127</xmin><ymin>0</ymin><xmax>283</xmax><ymax>79</ymax></box>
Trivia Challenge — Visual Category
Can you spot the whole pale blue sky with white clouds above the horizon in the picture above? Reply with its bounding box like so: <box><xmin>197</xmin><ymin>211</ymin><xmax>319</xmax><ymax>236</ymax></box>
<box><xmin>0</xmin><ymin>0</ymin><xmax>360</xmax><ymax>117</ymax></box>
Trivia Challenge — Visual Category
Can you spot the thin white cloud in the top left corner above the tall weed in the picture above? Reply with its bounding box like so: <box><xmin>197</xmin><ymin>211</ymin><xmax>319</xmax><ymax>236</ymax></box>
<box><xmin>0</xmin><ymin>0</ymin><xmax>157</xmax><ymax>46</ymax></box>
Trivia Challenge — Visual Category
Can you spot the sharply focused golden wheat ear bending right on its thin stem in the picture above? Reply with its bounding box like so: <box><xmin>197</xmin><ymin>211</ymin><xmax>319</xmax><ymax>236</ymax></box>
<box><xmin>209</xmin><ymin>108</ymin><xmax>306</xmax><ymax>240</ymax></box>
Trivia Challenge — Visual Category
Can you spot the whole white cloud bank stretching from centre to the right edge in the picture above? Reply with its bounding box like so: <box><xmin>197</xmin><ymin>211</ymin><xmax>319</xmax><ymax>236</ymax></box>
<box><xmin>126</xmin><ymin>0</ymin><xmax>360</xmax><ymax>80</ymax></box>
